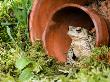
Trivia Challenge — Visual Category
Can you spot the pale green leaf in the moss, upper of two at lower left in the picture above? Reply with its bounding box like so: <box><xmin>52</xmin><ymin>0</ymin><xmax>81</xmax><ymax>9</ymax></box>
<box><xmin>15</xmin><ymin>58</ymin><xmax>31</xmax><ymax>70</ymax></box>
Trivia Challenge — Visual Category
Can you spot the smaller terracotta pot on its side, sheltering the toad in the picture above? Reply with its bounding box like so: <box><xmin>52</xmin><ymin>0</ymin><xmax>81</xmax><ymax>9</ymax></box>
<box><xmin>42</xmin><ymin>3</ymin><xmax>109</xmax><ymax>62</ymax></box>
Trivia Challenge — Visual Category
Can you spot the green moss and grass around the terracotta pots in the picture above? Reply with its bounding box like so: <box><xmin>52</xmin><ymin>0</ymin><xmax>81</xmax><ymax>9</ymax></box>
<box><xmin>0</xmin><ymin>0</ymin><xmax>110</xmax><ymax>82</ymax></box>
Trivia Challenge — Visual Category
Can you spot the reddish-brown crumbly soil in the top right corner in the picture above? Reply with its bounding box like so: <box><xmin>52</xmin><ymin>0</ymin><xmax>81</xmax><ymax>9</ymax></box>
<box><xmin>89</xmin><ymin>0</ymin><xmax>110</xmax><ymax>24</ymax></box>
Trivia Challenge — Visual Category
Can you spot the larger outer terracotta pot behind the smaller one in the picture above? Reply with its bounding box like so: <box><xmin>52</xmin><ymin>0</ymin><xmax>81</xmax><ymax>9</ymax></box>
<box><xmin>29</xmin><ymin>0</ymin><xmax>92</xmax><ymax>42</ymax></box>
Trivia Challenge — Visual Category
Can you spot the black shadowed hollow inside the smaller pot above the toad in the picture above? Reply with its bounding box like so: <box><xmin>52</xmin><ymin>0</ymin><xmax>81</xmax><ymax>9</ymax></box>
<box><xmin>52</xmin><ymin>6</ymin><xmax>94</xmax><ymax>29</ymax></box>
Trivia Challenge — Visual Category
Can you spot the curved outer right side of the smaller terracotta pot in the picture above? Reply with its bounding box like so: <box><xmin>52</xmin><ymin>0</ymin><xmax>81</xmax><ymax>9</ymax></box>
<box><xmin>82</xmin><ymin>8</ymin><xmax>109</xmax><ymax>47</ymax></box>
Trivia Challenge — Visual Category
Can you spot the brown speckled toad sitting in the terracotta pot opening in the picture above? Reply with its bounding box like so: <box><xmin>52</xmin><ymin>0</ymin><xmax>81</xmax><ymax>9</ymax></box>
<box><xmin>67</xmin><ymin>26</ymin><xmax>95</xmax><ymax>62</ymax></box>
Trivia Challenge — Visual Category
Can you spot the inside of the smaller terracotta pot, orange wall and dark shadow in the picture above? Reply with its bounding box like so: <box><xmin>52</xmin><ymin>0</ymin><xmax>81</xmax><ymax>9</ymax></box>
<box><xmin>45</xmin><ymin>7</ymin><xmax>94</xmax><ymax>61</ymax></box>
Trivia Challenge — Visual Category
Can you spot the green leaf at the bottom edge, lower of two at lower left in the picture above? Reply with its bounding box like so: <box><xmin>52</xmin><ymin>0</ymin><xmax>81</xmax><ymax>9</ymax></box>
<box><xmin>19</xmin><ymin>68</ymin><xmax>32</xmax><ymax>82</ymax></box>
